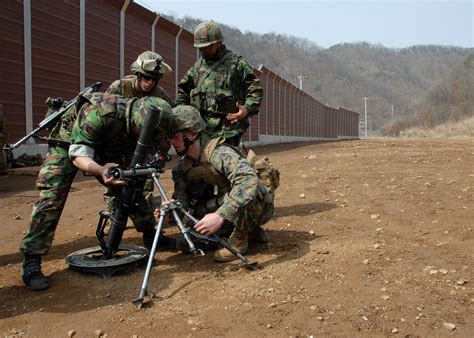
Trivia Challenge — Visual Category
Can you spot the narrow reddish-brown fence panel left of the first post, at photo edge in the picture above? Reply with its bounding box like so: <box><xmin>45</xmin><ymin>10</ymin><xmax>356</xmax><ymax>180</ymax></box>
<box><xmin>0</xmin><ymin>1</ymin><xmax>26</xmax><ymax>140</ymax></box>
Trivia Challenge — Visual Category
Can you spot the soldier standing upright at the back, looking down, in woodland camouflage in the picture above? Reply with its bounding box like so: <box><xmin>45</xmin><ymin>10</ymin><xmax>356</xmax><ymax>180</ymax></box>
<box><xmin>175</xmin><ymin>21</ymin><xmax>263</xmax><ymax>146</ymax></box>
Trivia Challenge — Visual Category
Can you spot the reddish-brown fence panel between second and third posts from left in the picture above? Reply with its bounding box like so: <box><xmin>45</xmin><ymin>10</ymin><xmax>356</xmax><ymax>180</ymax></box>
<box><xmin>85</xmin><ymin>1</ymin><xmax>121</xmax><ymax>91</ymax></box>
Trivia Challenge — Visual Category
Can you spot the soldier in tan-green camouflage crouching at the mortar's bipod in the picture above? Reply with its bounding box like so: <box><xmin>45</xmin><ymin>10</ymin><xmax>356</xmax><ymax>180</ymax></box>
<box><xmin>170</xmin><ymin>105</ymin><xmax>275</xmax><ymax>262</ymax></box>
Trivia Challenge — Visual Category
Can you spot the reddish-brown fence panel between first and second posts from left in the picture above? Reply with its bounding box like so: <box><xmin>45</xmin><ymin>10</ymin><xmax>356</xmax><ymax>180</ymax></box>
<box><xmin>31</xmin><ymin>0</ymin><xmax>80</xmax><ymax>127</ymax></box>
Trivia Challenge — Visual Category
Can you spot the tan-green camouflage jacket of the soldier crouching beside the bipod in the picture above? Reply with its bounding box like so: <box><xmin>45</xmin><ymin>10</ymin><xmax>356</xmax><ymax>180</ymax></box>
<box><xmin>172</xmin><ymin>137</ymin><xmax>268</xmax><ymax>224</ymax></box>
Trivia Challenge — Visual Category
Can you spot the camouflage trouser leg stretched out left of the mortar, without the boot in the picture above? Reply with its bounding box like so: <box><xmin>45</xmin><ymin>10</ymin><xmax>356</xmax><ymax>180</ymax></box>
<box><xmin>20</xmin><ymin>146</ymin><xmax>78</xmax><ymax>255</ymax></box>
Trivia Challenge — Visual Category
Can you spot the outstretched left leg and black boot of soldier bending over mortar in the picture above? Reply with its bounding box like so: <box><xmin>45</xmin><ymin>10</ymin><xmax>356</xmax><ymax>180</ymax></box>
<box><xmin>20</xmin><ymin>100</ymin><xmax>90</xmax><ymax>291</ymax></box>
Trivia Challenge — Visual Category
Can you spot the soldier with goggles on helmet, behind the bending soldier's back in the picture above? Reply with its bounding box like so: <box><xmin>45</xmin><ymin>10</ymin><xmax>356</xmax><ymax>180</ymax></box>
<box><xmin>107</xmin><ymin>51</ymin><xmax>173</xmax><ymax>105</ymax></box>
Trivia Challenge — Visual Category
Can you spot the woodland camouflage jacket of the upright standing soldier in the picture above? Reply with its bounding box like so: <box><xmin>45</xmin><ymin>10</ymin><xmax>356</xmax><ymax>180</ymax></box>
<box><xmin>175</xmin><ymin>45</ymin><xmax>263</xmax><ymax>138</ymax></box>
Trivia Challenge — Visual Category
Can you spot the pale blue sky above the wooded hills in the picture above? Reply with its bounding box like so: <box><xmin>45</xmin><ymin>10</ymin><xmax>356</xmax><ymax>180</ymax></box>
<box><xmin>135</xmin><ymin>0</ymin><xmax>474</xmax><ymax>48</ymax></box>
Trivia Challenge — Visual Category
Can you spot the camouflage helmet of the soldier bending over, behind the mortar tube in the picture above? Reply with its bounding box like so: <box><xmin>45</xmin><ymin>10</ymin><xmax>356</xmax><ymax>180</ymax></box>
<box><xmin>127</xmin><ymin>96</ymin><xmax>174</xmax><ymax>138</ymax></box>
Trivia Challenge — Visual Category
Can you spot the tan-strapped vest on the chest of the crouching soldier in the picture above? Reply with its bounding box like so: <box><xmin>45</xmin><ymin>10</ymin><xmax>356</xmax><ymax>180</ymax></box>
<box><xmin>181</xmin><ymin>137</ymin><xmax>230</xmax><ymax>212</ymax></box>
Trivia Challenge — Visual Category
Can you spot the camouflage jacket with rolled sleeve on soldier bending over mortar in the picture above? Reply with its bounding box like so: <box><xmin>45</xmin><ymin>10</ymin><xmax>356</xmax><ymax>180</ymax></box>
<box><xmin>69</xmin><ymin>93</ymin><xmax>167</xmax><ymax>166</ymax></box>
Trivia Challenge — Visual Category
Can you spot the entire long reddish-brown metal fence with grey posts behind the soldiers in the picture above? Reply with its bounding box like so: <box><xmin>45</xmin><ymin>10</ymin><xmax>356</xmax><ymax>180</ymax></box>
<box><xmin>0</xmin><ymin>0</ymin><xmax>359</xmax><ymax>153</ymax></box>
